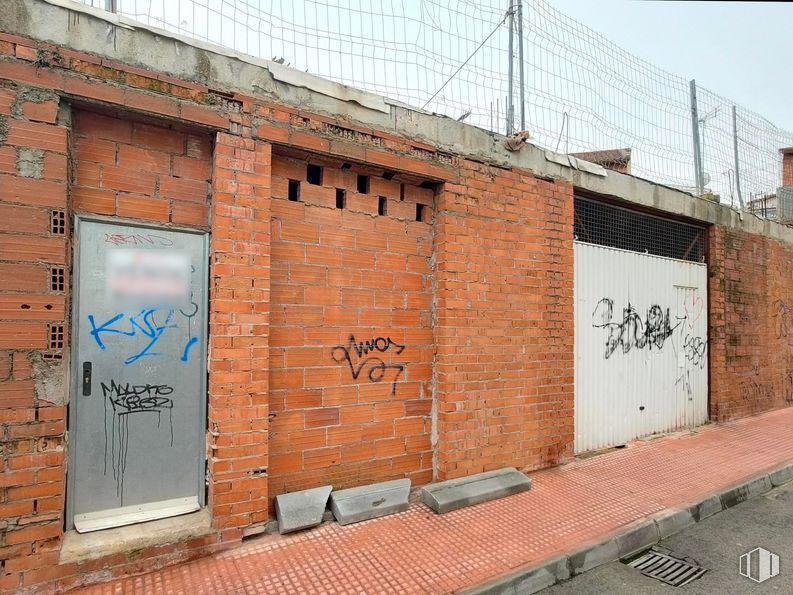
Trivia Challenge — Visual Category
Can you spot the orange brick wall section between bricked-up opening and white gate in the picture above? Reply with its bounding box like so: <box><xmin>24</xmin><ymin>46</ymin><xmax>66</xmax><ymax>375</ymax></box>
<box><xmin>435</xmin><ymin>163</ymin><xmax>574</xmax><ymax>479</ymax></box>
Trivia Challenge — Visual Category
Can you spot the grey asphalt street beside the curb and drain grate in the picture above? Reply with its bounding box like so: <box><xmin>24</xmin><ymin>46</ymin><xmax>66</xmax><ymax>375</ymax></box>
<box><xmin>542</xmin><ymin>482</ymin><xmax>793</xmax><ymax>595</ymax></box>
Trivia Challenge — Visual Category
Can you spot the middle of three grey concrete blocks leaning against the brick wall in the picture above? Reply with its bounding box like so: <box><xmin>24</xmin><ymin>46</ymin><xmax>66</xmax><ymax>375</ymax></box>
<box><xmin>330</xmin><ymin>479</ymin><xmax>410</xmax><ymax>525</ymax></box>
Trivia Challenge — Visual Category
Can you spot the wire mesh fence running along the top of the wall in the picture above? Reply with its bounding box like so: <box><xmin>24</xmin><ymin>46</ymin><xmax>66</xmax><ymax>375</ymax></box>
<box><xmin>74</xmin><ymin>0</ymin><xmax>793</xmax><ymax>214</ymax></box>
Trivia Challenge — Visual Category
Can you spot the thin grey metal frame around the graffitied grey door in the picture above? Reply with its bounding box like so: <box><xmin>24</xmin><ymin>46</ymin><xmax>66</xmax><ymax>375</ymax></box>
<box><xmin>65</xmin><ymin>214</ymin><xmax>211</xmax><ymax>531</ymax></box>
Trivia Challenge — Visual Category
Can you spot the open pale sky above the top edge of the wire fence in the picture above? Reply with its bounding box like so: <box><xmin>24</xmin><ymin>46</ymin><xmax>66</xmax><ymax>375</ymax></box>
<box><xmin>549</xmin><ymin>0</ymin><xmax>793</xmax><ymax>131</ymax></box>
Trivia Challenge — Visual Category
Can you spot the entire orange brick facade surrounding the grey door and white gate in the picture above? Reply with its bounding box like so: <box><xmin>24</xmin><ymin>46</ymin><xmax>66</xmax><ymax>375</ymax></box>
<box><xmin>0</xmin><ymin>22</ymin><xmax>793</xmax><ymax>591</ymax></box>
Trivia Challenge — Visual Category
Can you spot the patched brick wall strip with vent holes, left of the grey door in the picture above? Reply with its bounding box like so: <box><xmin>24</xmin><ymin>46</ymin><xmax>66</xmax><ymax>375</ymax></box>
<box><xmin>0</xmin><ymin>82</ymin><xmax>69</xmax><ymax>591</ymax></box>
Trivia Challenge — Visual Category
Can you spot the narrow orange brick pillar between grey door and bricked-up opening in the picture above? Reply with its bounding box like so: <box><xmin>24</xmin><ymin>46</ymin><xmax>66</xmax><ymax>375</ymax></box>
<box><xmin>208</xmin><ymin>130</ymin><xmax>271</xmax><ymax>541</ymax></box>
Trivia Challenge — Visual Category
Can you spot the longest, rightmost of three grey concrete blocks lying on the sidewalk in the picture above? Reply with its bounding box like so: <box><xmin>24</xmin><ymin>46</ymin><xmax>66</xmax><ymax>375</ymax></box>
<box><xmin>421</xmin><ymin>467</ymin><xmax>531</xmax><ymax>514</ymax></box>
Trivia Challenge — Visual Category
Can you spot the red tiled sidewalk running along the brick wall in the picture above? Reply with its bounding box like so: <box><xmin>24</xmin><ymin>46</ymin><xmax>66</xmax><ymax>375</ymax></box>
<box><xmin>72</xmin><ymin>408</ymin><xmax>793</xmax><ymax>594</ymax></box>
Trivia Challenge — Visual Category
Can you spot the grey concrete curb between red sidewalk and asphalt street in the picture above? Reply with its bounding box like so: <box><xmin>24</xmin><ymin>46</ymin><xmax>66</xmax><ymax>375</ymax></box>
<box><xmin>460</xmin><ymin>462</ymin><xmax>793</xmax><ymax>595</ymax></box>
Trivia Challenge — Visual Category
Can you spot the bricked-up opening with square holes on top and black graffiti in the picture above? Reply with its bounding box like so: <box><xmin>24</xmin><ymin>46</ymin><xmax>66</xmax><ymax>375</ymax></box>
<box><xmin>270</xmin><ymin>151</ymin><xmax>433</xmax><ymax>495</ymax></box>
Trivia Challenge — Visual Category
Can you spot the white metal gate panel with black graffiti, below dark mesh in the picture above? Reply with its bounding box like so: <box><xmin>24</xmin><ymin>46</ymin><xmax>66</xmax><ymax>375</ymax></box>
<box><xmin>574</xmin><ymin>242</ymin><xmax>708</xmax><ymax>452</ymax></box>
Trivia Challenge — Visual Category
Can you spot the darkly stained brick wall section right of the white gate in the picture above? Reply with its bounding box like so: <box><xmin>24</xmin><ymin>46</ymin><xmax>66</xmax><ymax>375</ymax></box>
<box><xmin>709</xmin><ymin>226</ymin><xmax>793</xmax><ymax>420</ymax></box>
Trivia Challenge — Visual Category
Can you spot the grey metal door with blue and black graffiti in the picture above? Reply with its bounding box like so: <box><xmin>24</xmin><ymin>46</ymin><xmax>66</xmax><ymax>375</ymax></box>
<box><xmin>67</xmin><ymin>218</ymin><xmax>207</xmax><ymax>532</ymax></box>
